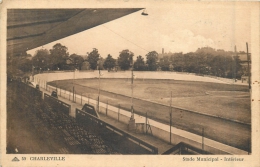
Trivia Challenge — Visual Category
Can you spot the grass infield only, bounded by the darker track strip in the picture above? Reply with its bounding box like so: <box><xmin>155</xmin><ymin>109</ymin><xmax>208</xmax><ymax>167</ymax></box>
<box><xmin>50</xmin><ymin>79</ymin><xmax>251</xmax><ymax>123</ymax></box>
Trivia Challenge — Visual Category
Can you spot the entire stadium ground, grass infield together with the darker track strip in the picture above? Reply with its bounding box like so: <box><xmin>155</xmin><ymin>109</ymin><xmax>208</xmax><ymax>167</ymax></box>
<box><xmin>50</xmin><ymin>78</ymin><xmax>251</xmax><ymax>150</ymax></box>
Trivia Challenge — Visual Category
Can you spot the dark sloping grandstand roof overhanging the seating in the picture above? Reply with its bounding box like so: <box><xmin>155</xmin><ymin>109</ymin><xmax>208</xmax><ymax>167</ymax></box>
<box><xmin>7</xmin><ymin>8</ymin><xmax>142</xmax><ymax>55</ymax></box>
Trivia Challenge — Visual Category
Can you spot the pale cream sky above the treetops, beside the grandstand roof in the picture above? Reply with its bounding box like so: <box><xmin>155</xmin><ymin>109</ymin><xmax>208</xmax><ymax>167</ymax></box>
<box><xmin>27</xmin><ymin>1</ymin><xmax>251</xmax><ymax>58</ymax></box>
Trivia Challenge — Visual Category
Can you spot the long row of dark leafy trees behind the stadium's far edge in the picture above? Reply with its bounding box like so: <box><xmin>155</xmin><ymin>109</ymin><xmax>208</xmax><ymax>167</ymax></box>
<box><xmin>9</xmin><ymin>43</ymin><xmax>245</xmax><ymax>78</ymax></box>
